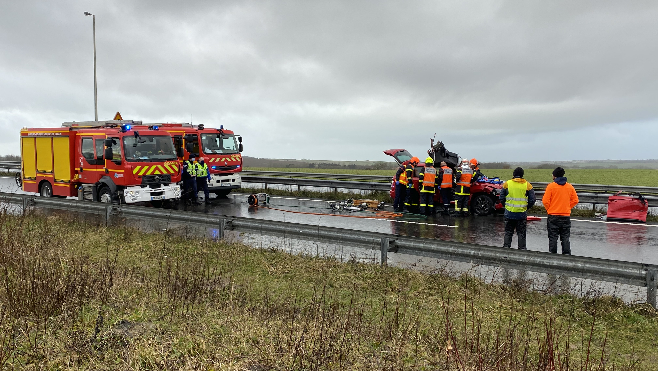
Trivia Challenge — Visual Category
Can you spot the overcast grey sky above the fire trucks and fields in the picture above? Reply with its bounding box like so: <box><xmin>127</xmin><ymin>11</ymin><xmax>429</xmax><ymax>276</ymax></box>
<box><xmin>0</xmin><ymin>0</ymin><xmax>658</xmax><ymax>162</ymax></box>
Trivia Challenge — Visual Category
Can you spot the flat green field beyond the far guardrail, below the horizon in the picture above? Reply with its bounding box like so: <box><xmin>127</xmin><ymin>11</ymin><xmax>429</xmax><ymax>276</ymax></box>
<box><xmin>245</xmin><ymin>167</ymin><xmax>658</xmax><ymax>187</ymax></box>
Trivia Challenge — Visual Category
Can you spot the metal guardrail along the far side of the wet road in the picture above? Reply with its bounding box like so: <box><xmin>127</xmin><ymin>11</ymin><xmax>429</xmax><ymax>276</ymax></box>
<box><xmin>242</xmin><ymin>170</ymin><xmax>658</xmax><ymax>205</ymax></box>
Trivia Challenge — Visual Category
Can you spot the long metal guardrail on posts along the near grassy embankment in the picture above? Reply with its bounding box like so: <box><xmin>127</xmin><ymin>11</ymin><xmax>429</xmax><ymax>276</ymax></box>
<box><xmin>0</xmin><ymin>193</ymin><xmax>658</xmax><ymax>308</ymax></box>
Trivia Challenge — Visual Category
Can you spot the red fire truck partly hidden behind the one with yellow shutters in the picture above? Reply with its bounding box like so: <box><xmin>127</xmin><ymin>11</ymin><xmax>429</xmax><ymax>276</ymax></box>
<box><xmin>157</xmin><ymin>123</ymin><xmax>243</xmax><ymax>197</ymax></box>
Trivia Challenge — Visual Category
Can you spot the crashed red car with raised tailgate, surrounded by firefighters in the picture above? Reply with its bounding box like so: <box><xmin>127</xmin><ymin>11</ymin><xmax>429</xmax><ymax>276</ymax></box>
<box><xmin>384</xmin><ymin>140</ymin><xmax>503</xmax><ymax>215</ymax></box>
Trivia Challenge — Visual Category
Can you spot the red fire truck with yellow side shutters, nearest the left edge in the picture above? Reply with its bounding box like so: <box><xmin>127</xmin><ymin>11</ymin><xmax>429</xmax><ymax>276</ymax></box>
<box><xmin>21</xmin><ymin>120</ymin><xmax>181</xmax><ymax>203</ymax></box>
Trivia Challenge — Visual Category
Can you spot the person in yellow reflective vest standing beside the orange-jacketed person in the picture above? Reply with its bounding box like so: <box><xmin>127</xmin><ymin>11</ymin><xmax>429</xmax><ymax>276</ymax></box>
<box><xmin>500</xmin><ymin>167</ymin><xmax>536</xmax><ymax>250</ymax></box>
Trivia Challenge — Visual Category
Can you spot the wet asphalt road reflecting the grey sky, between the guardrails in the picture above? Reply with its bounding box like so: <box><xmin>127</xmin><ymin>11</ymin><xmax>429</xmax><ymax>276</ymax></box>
<box><xmin>0</xmin><ymin>177</ymin><xmax>658</xmax><ymax>264</ymax></box>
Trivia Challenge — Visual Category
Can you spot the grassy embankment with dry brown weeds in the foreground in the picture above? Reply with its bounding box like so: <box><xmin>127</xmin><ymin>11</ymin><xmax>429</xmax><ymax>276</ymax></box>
<box><xmin>0</xmin><ymin>214</ymin><xmax>658</xmax><ymax>370</ymax></box>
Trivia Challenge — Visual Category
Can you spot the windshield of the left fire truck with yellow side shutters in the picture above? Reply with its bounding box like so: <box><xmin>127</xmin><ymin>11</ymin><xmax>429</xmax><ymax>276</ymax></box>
<box><xmin>123</xmin><ymin>135</ymin><xmax>178</xmax><ymax>162</ymax></box>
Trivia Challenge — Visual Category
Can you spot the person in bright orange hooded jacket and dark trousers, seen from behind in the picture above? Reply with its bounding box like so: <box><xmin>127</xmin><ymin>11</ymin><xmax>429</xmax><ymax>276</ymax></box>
<box><xmin>541</xmin><ymin>167</ymin><xmax>578</xmax><ymax>255</ymax></box>
